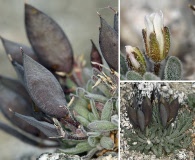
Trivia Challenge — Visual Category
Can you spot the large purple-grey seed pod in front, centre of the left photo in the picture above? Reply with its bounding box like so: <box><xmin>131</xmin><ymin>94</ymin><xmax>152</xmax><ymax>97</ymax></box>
<box><xmin>23</xmin><ymin>54</ymin><xmax>69</xmax><ymax>118</ymax></box>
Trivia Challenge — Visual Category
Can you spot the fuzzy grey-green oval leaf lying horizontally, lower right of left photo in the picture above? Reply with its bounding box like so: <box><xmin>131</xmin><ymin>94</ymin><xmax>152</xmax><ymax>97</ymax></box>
<box><xmin>87</xmin><ymin>120</ymin><xmax>118</xmax><ymax>132</ymax></box>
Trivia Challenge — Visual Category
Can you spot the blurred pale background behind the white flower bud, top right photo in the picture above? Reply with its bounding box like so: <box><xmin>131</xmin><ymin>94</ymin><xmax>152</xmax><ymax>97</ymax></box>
<box><xmin>120</xmin><ymin>0</ymin><xmax>195</xmax><ymax>80</ymax></box>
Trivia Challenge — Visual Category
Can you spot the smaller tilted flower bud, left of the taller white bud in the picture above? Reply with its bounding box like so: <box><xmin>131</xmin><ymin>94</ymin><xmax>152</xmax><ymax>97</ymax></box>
<box><xmin>125</xmin><ymin>46</ymin><xmax>146</xmax><ymax>75</ymax></box>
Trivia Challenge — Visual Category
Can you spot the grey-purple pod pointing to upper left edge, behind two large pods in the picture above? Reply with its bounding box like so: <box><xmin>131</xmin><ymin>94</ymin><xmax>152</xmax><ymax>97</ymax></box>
<box><xmin>1</xmin><ymin>37</ymin><xmax>38</xmax><ymax>65</ymax></box>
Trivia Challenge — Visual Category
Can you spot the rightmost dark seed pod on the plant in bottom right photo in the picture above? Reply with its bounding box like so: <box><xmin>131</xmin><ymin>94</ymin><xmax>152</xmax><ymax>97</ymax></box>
<box><xmin>168</xmin><ymin>98</ymin><xmax>180</xmax><ymax>123</ymax></box>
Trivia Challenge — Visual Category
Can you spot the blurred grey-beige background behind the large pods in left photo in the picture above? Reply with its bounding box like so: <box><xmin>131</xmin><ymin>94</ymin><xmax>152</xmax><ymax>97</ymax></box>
<box><xmin>0</xmin><ymin>0</ymin><xmax>118</xmax><ymax>160</ymax></box>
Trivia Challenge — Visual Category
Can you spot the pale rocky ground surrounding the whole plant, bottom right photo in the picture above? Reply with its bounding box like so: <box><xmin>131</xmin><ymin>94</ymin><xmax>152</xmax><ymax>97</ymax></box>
<box><xmin>120</xmin><ymin>82</ymin><xmax>195</xmax><ymax>160</ymax></box>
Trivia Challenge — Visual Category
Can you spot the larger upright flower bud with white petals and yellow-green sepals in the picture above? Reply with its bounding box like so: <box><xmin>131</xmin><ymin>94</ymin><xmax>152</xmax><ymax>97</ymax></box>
<box><xmin>142</xmin><ymin>11</ymin><xmax>170</xmax><ymax>63</ymax></box>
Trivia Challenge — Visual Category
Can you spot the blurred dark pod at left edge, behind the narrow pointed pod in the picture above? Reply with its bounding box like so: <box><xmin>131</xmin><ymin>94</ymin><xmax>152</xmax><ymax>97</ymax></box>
<box><xmin>0</xmin><ymin>77</ymin><xmax>40</xmax><ymax>136</ymax></box>
